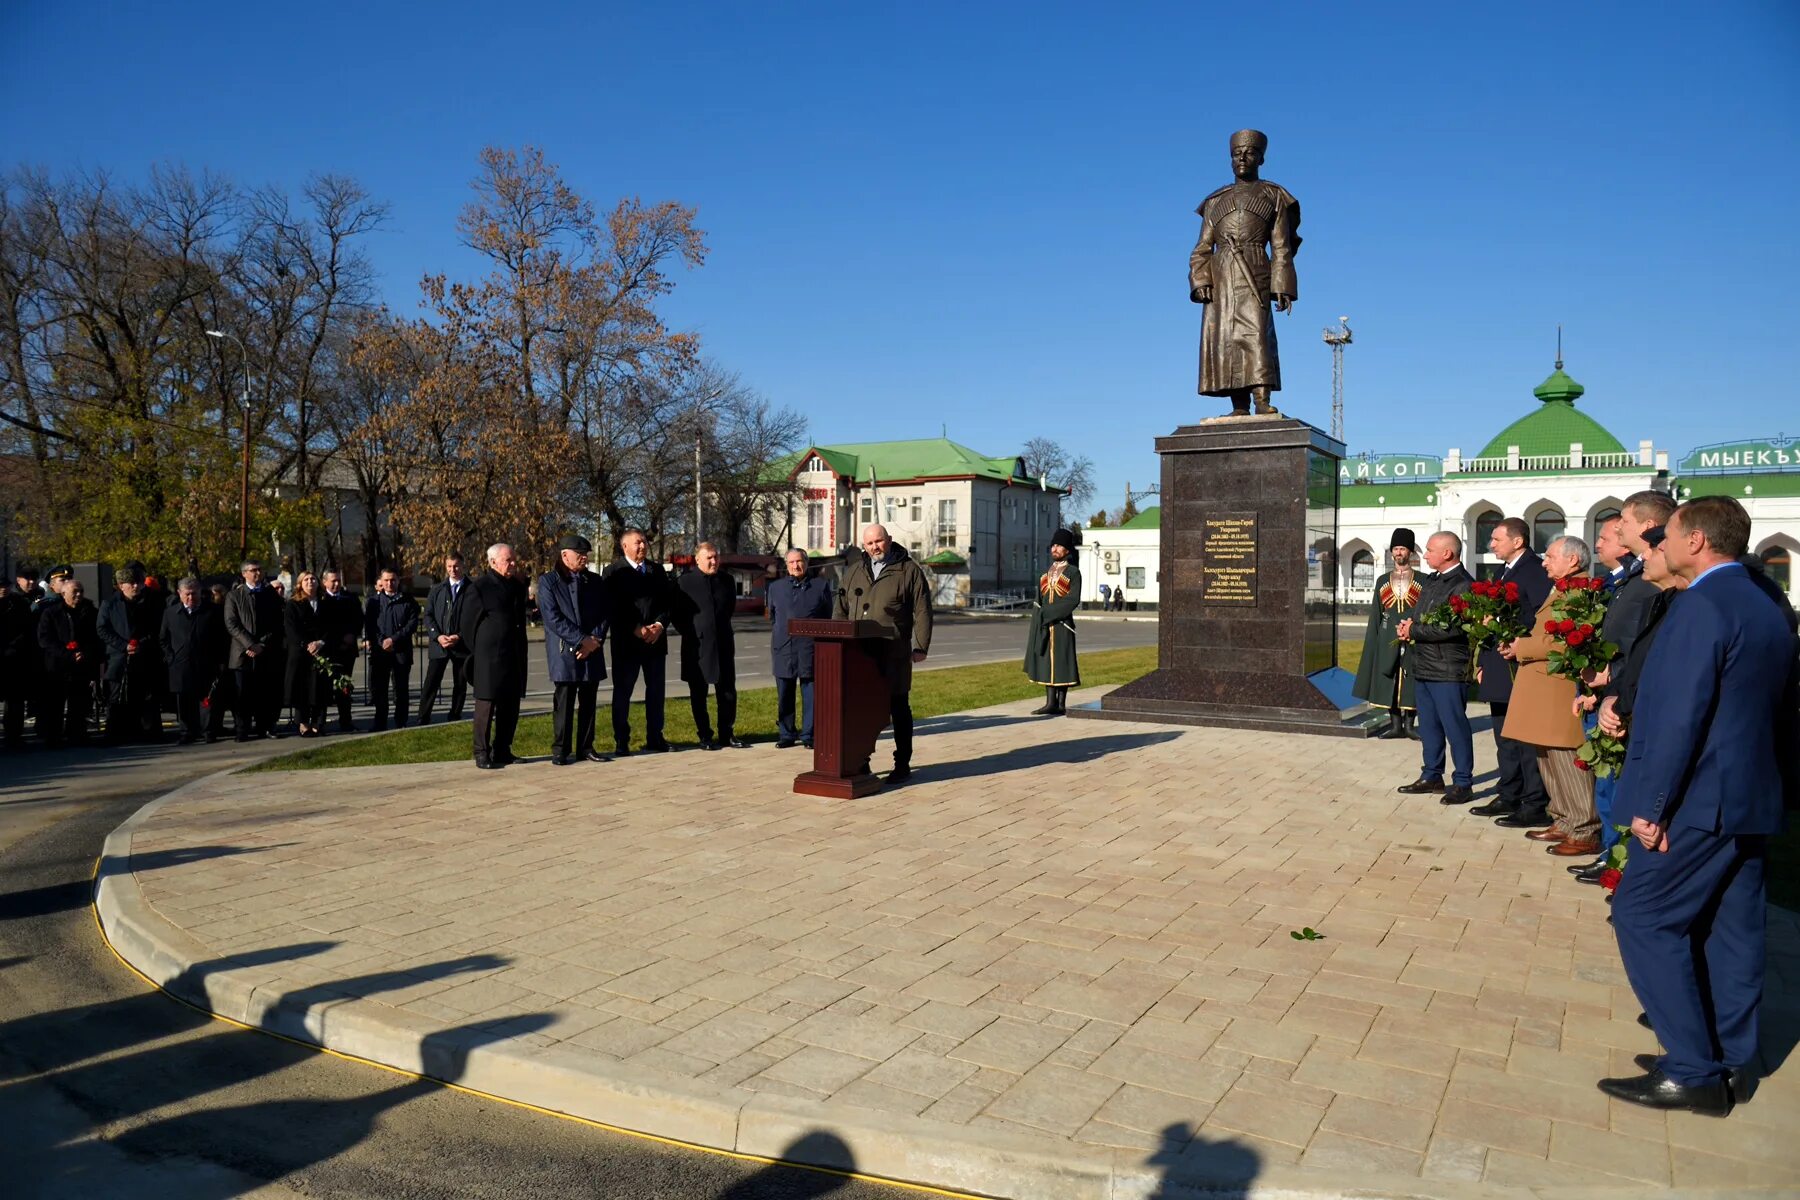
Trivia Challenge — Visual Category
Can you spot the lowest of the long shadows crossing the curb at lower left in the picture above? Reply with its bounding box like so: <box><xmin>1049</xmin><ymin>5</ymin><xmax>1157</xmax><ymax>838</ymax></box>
<box><xmin>61</xmin><ymin>1013</ymin><xmax>556</xmax><ymax>1200</ymax></box>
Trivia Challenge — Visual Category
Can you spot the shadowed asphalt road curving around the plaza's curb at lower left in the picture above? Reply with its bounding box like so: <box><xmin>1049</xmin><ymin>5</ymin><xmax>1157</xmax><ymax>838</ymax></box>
<box><xmin>0</xmin><ymin>766</ymin><xmax>920</xmax><ymax>1200</ymax></box>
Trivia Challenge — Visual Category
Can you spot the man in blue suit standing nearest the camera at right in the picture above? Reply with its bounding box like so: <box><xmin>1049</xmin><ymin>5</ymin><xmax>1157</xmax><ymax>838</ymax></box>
<box><xmin>1600</xmin><ymin>497</ymin><xmax>1795</xmax><ymax>1115</ymax></box>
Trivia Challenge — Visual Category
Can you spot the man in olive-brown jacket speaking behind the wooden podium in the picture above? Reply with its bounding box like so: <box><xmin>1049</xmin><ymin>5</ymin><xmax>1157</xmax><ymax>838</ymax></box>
<box><xmin>837</xmin><ymin>525</ymin><xmax>931</xmax><ymax>784</ymax></box>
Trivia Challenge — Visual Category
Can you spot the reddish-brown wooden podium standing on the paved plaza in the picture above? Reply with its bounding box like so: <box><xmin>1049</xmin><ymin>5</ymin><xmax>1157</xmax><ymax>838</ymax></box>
<box><xmin>788</xmin><ymin>621</ymin><xmax>893</xmax><ymax>801</ymax></box>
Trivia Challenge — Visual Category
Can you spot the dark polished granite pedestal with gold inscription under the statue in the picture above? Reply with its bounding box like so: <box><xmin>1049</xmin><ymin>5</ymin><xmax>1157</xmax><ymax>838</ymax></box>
<box><xmin>1069</xmin><ymin>416</ymin><xmax>1386</xmax><ymax>738</ymax></box>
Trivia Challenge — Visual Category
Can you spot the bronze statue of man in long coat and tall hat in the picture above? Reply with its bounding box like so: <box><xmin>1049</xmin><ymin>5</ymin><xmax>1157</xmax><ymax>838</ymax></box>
<box><xmin>1188</xmin><ymin>130</ymin><xmax>1300</xmax><ymax>416</ymax></box>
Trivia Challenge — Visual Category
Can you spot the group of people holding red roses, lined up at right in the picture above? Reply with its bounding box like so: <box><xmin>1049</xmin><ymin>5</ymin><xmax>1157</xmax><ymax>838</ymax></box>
<box><xmin>1372</xmin><ymin>491</ymin><xmax>1800</xmax><ymax>1115</ymax></box>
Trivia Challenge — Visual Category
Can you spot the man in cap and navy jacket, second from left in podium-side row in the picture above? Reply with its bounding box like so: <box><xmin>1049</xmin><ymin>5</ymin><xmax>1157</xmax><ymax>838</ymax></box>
<box><xmin>538</xmin><ymin>533</ymin><xmax>608</xmax><ymax>766</ymax></box>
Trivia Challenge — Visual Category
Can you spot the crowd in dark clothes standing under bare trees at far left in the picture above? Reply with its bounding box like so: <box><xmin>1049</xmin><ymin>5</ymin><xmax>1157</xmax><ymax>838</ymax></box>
<box><xmin>0</xmin><ymin>554</ymin><xmax>468</xmax><ymax>750</ymax></box>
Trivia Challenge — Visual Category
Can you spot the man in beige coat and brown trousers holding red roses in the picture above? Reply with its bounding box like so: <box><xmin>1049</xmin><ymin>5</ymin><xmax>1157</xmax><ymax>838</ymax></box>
<box><xmin>1499</xmin><ymin>536</ymin><xmax>1600</xmax><ymax>858</ymax></box>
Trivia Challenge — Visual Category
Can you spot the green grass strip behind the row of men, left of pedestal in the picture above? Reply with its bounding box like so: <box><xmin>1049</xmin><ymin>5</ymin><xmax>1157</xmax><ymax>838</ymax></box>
<box><xmin>250</xmin><ymin>646</ymin><xmax>1156</xmax><ymax>770</ymax></box>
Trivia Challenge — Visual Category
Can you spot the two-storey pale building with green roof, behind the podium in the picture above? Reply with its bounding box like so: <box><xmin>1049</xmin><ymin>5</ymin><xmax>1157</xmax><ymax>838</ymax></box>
<box><xmin>756</xmin><ymin>437</ymin><xmax>1067</xmax><ymax>606</ymax></box>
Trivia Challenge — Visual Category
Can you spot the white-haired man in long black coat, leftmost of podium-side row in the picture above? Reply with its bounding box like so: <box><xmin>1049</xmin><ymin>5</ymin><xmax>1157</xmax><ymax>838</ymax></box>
<box><xmin>455</xmin><ymin>542</ymin><xmax>529</xmax><ymax>770</ymax></box>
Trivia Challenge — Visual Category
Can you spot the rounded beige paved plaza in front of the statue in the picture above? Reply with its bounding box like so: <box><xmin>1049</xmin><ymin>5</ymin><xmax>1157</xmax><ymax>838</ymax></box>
<box><xmin>101</xmin><ymin>696</ymin><xmax>1800</xmax><ymax>1200</ymax></box>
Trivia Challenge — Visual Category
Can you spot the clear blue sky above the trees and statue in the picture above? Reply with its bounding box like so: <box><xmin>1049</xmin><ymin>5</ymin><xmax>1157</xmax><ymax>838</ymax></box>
<box><xmin>0</xmin><ymin>0</ymin><xmax>1800</xmax><ymax>507</ymax></box>
